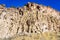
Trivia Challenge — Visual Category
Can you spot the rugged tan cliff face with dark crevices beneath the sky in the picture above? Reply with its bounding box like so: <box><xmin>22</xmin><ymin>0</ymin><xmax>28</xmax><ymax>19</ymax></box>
<box><xmin>0</xmin><ymin>3</ymin><xmax>60</xmax><ymax>40</ymax></box>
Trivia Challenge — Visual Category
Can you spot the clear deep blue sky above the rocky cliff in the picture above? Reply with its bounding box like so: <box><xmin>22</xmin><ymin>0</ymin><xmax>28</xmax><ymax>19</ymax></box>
<box><xmin>0</xmin><ymin>0</ymin><xmax>60</xmax><ymax>11</ymax></box>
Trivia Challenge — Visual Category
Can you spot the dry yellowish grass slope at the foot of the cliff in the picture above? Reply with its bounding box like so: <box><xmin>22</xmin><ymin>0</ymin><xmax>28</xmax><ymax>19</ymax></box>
<box><xmin>11</xmin><ymin>32</ymin><xmax>60</xmax><ymax>40</ymax></box>
